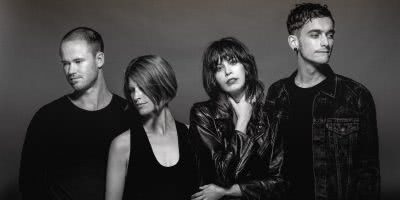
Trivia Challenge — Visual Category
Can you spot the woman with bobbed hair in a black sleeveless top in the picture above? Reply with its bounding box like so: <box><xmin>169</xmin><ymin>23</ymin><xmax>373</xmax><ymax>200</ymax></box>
<box><xmin>106</xmin><ymin>55</ymin><xmax>197</xmax><ymax>200</ymax></box>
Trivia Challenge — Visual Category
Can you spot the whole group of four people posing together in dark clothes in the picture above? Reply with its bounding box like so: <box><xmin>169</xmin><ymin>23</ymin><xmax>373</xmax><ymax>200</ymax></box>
<box><xmin>20</xmin><ymin>3</ymin><xmax>380</xmax><ymax>200</ymax></box>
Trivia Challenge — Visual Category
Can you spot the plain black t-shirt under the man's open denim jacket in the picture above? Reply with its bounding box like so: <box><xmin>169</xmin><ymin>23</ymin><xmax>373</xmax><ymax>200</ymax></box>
<box><xmin>284</xmin><ymin>80</ymin><xmax>325</xmax><ymax>199</ymax></box>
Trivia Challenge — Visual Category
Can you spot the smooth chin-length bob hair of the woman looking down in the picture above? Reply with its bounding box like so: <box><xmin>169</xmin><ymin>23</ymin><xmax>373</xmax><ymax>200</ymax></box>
<box><xmin>124</xmin><ymin>55</ymin><xmax>178</xmax><ymax>111</ymax></box>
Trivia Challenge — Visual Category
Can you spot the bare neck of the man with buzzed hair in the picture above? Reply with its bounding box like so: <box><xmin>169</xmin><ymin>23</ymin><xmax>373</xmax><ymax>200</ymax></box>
<box><xmin>69</xmin><ymin>71</ymin><xmax>112</xmax><ymax>111</ymax></box>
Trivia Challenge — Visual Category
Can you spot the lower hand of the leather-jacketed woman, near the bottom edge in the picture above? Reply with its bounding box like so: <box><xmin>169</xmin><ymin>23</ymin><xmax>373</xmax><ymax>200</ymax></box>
<box><xmin>191</xmin><ymin>184</ymin><xmax>226</xmax><ymax>200</ymax></box>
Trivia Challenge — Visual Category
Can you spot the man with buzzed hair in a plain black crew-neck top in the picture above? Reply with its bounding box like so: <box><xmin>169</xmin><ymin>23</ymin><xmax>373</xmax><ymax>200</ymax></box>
<box><xmin>19</xmin><ymin>27</ymin><xmax>126</xmax><ymax>200</ymax></box>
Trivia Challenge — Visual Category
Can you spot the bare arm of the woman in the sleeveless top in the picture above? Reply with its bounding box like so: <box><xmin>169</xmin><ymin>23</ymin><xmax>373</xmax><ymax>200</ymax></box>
<box><xmin>106</xmin><ymin>130</ymin><xmax>130</xmax><ymax>200</ymax></box>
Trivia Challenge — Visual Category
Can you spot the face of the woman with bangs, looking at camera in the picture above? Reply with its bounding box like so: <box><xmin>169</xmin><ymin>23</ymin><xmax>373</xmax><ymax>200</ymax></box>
<box><xmin>215</xmin><ymin>59</ymin><xmax>246</xmax><ymax>96</ymax></box>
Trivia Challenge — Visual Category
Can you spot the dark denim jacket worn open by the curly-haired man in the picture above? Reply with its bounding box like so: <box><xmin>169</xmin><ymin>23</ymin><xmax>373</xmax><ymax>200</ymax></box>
<box><xmin>265</xmin><ymin>65</ymin><xmax>380</xmax><ymax>200</ymax></box>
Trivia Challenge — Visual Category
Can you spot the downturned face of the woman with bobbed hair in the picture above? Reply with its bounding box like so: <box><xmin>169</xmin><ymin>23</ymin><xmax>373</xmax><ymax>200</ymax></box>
<box><xmin>129</xmin><ymin>79</ymin><xmax>156</xmax><ymax>116</ymax></box>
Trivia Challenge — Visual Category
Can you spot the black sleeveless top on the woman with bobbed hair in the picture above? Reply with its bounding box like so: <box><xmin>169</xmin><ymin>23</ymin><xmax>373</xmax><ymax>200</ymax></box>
<box><xmin>123</xmin><ymin>121</ymin><xmax>198</xmax><ymax>200</ymax></box>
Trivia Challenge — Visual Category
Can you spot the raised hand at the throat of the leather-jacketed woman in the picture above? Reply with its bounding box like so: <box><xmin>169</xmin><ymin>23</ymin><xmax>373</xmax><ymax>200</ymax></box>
<box><xmin>228</xmin><ymin>95</ymin><xmax>253</xmax><ymax>133</ymax></box>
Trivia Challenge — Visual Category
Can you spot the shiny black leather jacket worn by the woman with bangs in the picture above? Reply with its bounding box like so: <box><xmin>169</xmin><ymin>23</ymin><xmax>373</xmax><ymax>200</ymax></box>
<box><xmin>189</xmin><ymin>101</ymin><xmax>286</xmax><ymax>199</ymax></box>
